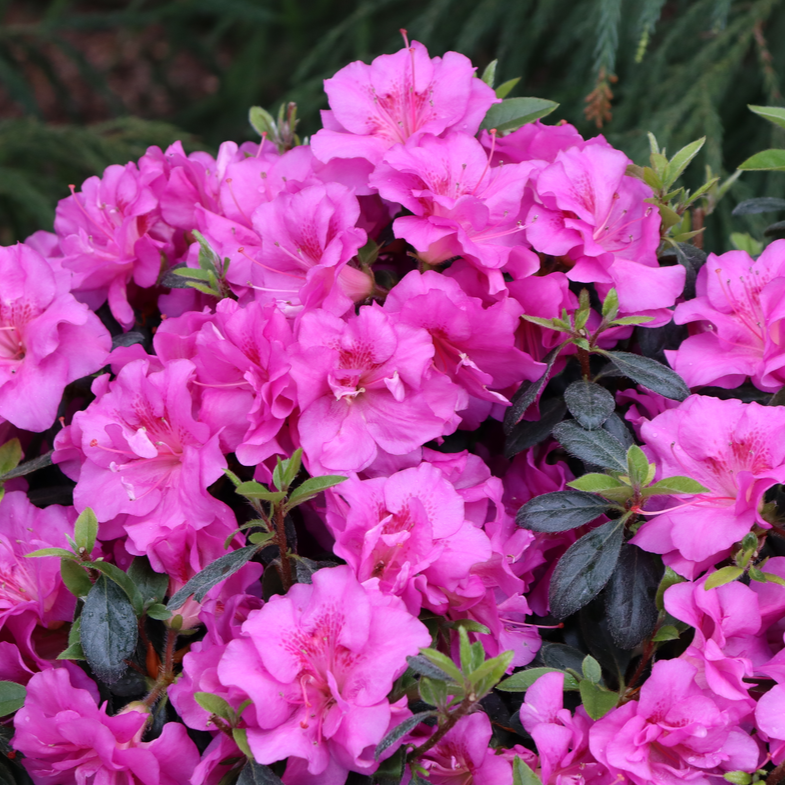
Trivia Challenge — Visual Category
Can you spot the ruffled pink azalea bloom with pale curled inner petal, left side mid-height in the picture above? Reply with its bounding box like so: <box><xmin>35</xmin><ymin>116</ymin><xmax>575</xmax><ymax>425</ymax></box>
<box><xmin>53</xmin><ymin>358</ymin><xmax>236</xmax><ymax>580</ymax></box>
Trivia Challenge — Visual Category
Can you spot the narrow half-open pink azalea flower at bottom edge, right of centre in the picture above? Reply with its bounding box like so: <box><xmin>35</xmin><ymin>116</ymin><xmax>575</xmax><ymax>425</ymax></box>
<box><xmin>519</xmin><ymin>673</ymin><xmax>616</xmax><ymax>785</ymax></box>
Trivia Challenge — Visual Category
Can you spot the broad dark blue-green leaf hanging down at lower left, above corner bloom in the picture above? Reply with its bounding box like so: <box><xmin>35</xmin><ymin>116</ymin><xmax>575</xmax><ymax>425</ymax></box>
<box><xmin>80</xmin><ymin>575</ymin><xmax>138</xmax><ymax>684</ymax></box>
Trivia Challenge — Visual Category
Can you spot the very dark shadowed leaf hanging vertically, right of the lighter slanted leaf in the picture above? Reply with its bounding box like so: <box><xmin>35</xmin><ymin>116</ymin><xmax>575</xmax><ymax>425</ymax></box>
<box><xmin>605</xmin><ymin>543</ymin><xmax>663</xmax><ymax>649</ymax></box>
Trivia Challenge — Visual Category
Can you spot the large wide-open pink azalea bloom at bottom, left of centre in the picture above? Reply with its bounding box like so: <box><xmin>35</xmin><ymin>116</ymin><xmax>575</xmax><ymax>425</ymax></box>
<box><xmin>218</xmin><ymin>566</ymin><xmax>431</xmax><ymax>785</ymax></box>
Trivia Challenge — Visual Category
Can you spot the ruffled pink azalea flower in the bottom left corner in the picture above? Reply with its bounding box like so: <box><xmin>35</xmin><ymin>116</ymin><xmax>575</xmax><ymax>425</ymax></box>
<box><xmin>13</xmin><ymin>668</ymin><xmax>199</xmax><ymax>785</ymax></box>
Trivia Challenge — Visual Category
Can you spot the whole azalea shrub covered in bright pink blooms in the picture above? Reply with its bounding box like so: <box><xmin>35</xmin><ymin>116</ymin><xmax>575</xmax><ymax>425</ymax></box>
<box><xmin>0</xmin><ymin>36</ymin><xmax>785</xmax><ymax>785</ymax></box>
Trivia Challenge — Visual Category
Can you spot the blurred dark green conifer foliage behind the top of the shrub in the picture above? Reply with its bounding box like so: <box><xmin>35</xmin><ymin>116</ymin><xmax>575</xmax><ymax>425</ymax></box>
<box><xmin>0</xmin><ymin>0</ymin><xmax>785</xmax><ymax>250</ymax></box>
